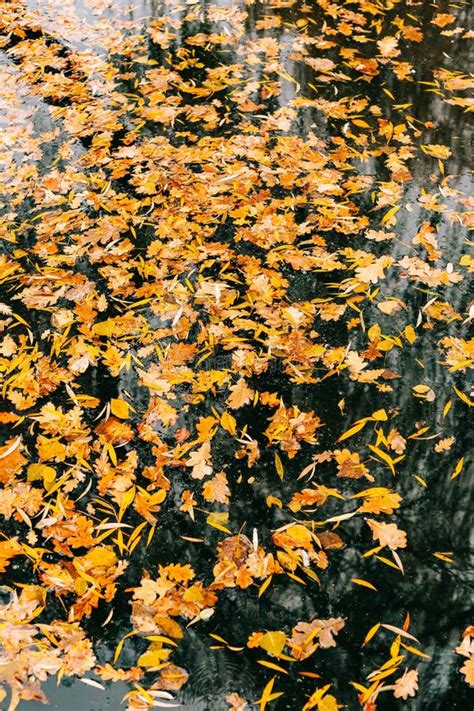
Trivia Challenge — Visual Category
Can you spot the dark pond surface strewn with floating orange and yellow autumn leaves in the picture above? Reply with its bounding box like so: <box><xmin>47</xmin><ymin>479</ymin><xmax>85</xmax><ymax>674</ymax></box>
<box><xmin>0</xmin><ymin>0</ymin><xmax>474</xmax><ymax>711</ymax></box>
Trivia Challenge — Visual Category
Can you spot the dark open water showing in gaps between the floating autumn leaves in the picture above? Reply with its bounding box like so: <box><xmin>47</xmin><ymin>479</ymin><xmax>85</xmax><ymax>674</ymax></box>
<box><xmin>1</xmin><ymin>2</ymin><xmax>474</xmax><ymax>711</ymax></box>
